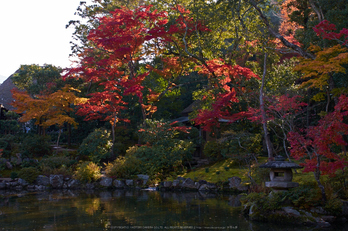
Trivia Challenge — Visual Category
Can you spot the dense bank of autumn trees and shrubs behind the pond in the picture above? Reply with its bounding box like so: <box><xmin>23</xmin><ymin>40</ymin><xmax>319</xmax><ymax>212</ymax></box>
<box><xmin>0</xmin><ymin>0</ymin><xmax>348</xmax><ymax>202</ymax></box>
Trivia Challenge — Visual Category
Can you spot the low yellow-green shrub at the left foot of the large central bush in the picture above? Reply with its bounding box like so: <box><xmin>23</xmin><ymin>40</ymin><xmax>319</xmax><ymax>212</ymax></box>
<box><xmin>105</xmin><ymin>155</ymin><xmax>143</xmax><ymax>179</ymax></box>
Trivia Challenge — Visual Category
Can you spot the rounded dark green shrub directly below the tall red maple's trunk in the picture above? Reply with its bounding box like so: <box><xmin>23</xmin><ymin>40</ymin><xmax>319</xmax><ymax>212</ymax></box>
<box><xmin>78</xmin><ymin>128</ymin><xmax>112</xmax><ymax>163</ymax></box>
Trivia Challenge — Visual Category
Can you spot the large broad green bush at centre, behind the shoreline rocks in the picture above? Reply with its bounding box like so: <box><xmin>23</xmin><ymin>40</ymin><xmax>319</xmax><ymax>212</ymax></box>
<box><xmin>135</xmin><ymin>120</ymin><xmax>198</xmax><ymax>178</ymax></box>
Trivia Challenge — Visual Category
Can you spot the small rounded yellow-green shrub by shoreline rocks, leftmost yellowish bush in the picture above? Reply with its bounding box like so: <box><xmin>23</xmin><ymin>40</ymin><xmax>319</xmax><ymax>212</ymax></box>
<box><xmin>74</xmin><ymin>161</ymin><xmax>101</xmax><ymax>183</ymax></box>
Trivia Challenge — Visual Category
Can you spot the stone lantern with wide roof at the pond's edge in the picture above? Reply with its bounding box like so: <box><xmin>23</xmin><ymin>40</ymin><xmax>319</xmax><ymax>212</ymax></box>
<box><xmin>260</xmin><ymin>156</ymin><xmax>302</xmax><ymax>191</ymax></box>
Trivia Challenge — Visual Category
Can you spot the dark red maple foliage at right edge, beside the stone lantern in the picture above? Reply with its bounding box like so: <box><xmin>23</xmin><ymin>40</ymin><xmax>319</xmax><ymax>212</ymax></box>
<box><xmin>289</xmin><ymin>95</ymin><xmax>348</xmax><ymax>175</ymax></box>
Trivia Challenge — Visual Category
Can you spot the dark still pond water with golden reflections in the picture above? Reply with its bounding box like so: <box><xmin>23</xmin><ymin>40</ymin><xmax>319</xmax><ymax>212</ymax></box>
<box><xmin>0</xmin><ymin>190</ymin><xmax>345</xmax><ymax>231</ymax></box>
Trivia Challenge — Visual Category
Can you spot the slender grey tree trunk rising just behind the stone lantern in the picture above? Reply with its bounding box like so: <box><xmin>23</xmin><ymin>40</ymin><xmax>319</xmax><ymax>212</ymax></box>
<box><xmin>260</xmin><ymin>53</ymin><xmax>273</xmax><ymax>159</ymax></box>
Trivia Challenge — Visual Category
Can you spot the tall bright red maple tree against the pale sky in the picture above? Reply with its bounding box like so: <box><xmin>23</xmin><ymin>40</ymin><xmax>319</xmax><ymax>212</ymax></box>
<box><xmin>65</xmin><ymin>5</ymin><xmax>211</xmax><ymax>152</ymax></box>
